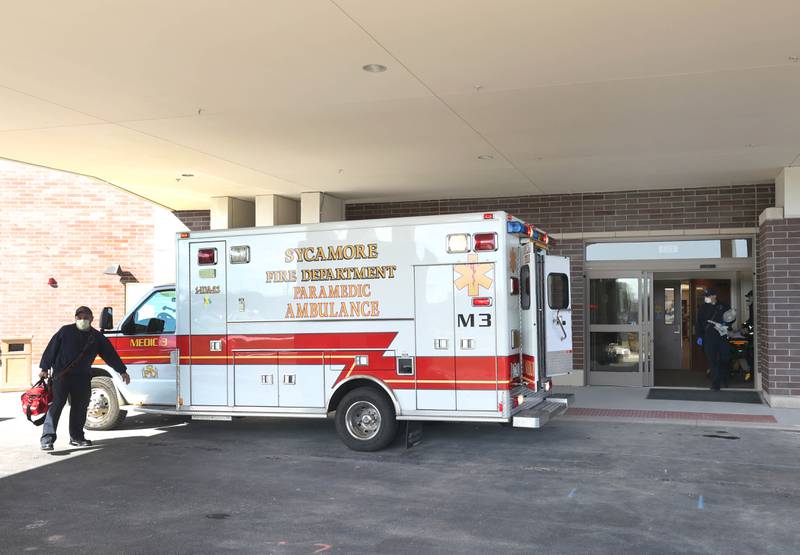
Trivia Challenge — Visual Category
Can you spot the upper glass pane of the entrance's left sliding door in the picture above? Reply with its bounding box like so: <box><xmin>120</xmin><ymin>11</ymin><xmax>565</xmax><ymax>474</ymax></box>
<box><xmin>589</xmin><ymin>278</ymin><xmax>639</xmax><ymax>324</ymax></box>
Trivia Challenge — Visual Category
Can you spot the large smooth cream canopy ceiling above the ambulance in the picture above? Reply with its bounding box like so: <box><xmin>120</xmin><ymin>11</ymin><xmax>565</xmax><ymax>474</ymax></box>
<box><xmin>0</xmin><ymin>0</ymin><xmax>800</xmax><ymax>208</ymax></box>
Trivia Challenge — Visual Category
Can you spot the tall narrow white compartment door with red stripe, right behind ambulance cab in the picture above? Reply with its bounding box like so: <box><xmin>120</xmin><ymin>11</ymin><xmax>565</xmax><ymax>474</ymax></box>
<box><xmin>191</xmin><ymin>241</ymin><xmax>229</xmax><ymax>407</ymax></box>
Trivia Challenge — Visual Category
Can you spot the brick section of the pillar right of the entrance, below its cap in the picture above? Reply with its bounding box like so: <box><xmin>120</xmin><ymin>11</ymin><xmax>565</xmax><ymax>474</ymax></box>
<box><xmin>756</xmin><ymin>219</ymin><xmax>800</xmax><ymax>395</ymax></box>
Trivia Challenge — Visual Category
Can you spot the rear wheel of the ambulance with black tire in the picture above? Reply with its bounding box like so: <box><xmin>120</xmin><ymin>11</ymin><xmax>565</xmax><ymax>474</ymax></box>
<box><xmin>336</xmin><ymin>387</ymin><xmax>397</xmax><ymax>451</ymax></box>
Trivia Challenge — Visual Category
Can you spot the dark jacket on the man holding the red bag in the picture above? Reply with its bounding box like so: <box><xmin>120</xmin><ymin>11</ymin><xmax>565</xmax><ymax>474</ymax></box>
<box><xmin>39</xmin><ymin>324</ymin><xmax>127</xmax><ymax>377</ymax></box>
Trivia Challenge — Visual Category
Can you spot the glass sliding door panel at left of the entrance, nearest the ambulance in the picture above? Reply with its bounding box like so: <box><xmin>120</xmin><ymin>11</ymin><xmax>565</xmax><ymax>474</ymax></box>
<box><xmin>587</xmin><ymin>272</ymin><xmax>653</xmax><ymax>386</ymax></box>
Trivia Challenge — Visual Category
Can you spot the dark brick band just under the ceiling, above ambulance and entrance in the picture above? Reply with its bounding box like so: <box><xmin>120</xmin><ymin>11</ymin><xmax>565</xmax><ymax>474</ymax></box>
<box><xmin>346</xmin><ymin>184</ymin><xmax>775</xmax><ymax>233</ymax></box>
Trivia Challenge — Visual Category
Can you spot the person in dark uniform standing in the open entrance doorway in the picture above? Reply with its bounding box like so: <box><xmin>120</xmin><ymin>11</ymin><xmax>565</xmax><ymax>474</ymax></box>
<box><xmin>695</xmin><ymin>289</ymin><xmax>731</xmax><ymax>391</ymax></box>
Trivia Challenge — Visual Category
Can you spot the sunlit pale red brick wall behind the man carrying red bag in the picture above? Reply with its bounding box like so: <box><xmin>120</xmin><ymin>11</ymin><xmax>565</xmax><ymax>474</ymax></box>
<box><xmin>0</xmin><ymin>161</ymin><xmax>154</xmax><ymax>378</ymax></box>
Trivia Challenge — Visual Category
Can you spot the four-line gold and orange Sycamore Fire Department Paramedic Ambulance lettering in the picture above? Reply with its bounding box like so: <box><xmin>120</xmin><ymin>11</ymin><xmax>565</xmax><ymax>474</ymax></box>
<box><xmin>266</xmin><ymin>243</ymin><xmax>397</xmax><ymax>320</ymax></box>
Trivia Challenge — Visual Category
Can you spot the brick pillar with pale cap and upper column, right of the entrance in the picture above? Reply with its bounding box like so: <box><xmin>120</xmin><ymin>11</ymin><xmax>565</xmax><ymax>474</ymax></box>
<box><xmin>755</xmin><ymin>168</ymin><xmax>800</xmax><ymax>408</ymax></box>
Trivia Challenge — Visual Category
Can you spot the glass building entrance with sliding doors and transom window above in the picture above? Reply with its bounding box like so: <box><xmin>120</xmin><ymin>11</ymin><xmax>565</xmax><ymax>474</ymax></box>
<box><xmin>586</xmin><ymin>238</ymin><xmax>760</xmax><ymax>390</ymax></box>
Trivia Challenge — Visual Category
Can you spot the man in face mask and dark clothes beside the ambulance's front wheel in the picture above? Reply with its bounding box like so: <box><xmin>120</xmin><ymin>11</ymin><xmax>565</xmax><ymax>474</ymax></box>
<box><xmin>39</xmin><ymin>306</ymin><xmax>131</xmax><ymax>451</ymax></box>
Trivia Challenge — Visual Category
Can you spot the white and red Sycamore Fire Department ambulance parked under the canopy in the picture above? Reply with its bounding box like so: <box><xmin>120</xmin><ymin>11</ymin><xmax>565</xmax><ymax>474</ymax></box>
<box><xmin>87</xmin><ymin>212</ymin><xmax>572</xmax><ymax>451</ymax></box>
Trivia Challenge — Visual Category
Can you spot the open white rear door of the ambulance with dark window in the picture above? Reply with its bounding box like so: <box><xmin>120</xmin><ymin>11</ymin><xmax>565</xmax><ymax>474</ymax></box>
<box><xmin>536</xmin><ymin>253</ymin><xmax>572</xmax><ymax>377</ymax></box>
